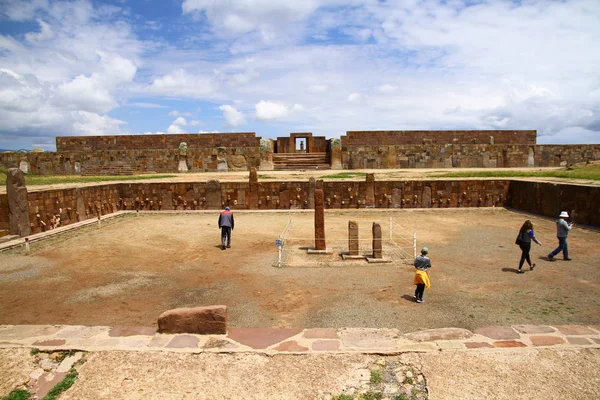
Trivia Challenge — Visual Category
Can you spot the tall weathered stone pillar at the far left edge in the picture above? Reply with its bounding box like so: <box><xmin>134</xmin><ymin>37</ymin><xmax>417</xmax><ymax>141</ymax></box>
<box><xmin>6</xmin><ymin>168</ymin><xmax>31</xmax><ymax>237</ymax></box>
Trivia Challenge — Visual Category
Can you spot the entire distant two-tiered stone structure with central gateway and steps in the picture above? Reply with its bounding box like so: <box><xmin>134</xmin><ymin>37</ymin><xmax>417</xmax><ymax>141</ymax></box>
<box><xmin>0</xmin><ymin>130</ymin><xmax>600</xmax><ymax>175</ymax></box>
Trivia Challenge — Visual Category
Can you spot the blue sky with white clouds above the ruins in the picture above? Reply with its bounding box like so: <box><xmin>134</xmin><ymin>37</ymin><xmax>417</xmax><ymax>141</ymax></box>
<box><xmin>0</xmin><ymin>0</ymin><xmax>600</xmax><ymax>151</ymax></box>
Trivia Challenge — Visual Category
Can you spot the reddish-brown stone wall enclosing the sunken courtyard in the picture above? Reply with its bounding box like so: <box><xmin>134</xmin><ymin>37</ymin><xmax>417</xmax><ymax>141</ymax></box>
<box><xmin>0</xmin><ymin>175</ymin><xmax>600</xmax><ymax>233</ymax></box>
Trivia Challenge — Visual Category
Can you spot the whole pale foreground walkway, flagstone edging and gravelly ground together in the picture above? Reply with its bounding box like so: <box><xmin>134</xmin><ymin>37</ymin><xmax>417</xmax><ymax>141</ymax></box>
<box><xmin>0</xmin><ymin>325</ymin><xmax>600</xmax><ymax>399</ymax></box>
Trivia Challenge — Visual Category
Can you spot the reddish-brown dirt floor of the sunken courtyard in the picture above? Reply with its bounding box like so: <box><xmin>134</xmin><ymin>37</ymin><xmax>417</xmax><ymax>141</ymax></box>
<box><xmin>0</xmin><ymin>209</ymin><xmax>600</xmax><ymax>332</ymax></box>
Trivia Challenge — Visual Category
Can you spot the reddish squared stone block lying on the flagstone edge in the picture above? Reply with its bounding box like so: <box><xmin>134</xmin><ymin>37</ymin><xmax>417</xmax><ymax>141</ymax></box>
<box><xmin>158</xmin><ymin>306</ymin><xmax>227</xmax><ymax>335</ymax></box>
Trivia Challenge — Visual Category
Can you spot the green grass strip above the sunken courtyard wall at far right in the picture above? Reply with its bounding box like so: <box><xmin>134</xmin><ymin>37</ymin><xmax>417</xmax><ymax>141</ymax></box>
<box><xmin>431</xmin><ymin>164</ymin><xmax>600</xmax><ymax>181</ymax></box>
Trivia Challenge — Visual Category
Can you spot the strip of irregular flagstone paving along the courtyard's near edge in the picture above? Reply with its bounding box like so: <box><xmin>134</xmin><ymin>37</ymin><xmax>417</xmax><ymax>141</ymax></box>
<box><xmin>0</xmin><ymin>325</ymin><xmax>600</xmax><ymax>354</ymax></box>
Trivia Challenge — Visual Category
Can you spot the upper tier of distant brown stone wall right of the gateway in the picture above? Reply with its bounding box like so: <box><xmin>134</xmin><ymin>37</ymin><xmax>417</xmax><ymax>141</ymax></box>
<box><xmin>342</xmin><ymin>130</ymin><xmax>537</xmax><ymax>146</ymax></box>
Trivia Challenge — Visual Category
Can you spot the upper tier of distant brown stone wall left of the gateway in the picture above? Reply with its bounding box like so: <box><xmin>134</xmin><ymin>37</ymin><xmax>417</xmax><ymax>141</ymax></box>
<box><xmin>56</xmin><ymin>132</ymin><xmax>260</xmax><ymax>152</ymax></box>
